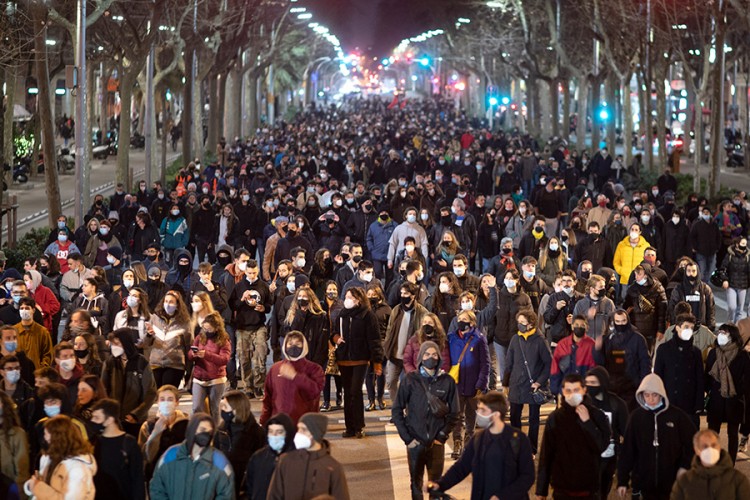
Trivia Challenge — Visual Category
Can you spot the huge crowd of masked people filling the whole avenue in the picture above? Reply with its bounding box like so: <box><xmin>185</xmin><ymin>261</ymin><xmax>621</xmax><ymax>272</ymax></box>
<box><xmin>0</xmin><ymin>95</ymin><xmax>750</xmax><ymax>500</ymax></box>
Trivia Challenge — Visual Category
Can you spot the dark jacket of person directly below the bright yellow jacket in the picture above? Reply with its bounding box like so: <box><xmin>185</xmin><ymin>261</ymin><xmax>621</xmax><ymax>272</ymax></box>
<box><xmin>624</xmin><ymin>276</ymin><xmax>667</xmax><ymax>339</ymax></box>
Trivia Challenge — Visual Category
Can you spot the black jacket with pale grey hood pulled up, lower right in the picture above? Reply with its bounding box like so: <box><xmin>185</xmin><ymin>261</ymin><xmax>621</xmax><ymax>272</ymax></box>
<box><xmin>617</xmin><ymin>373</ymin><xmax>696</xmax><ymax>496</ymax></box>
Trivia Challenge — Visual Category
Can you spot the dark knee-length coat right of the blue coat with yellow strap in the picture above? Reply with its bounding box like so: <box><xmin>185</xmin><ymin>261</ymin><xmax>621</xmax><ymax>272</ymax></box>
<box><xmin>503</xmin><ymin>333</ymin><xmax>552</xmax><ymax>404</ymax></box>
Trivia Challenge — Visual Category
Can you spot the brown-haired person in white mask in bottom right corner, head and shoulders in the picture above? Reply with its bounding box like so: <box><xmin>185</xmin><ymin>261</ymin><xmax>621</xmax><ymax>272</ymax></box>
<box><xmin>671</xmin><ymin>429</ymin><xmax>750</xmax><ymax>500</ymax></box>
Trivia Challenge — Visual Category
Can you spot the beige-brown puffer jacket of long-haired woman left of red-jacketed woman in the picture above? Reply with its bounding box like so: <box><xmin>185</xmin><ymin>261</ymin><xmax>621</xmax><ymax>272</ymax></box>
<box><xmin>143</xmin><ymin>315</ymin><xmax>193</xmax><ymax>370</ymax></box>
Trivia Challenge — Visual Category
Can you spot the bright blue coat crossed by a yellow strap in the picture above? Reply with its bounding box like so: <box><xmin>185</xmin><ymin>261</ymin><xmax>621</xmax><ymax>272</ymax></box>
<box><xmin>448</xmin><ymin>327</ymin><xmax>490</xmax><ymax>397</ymax></box>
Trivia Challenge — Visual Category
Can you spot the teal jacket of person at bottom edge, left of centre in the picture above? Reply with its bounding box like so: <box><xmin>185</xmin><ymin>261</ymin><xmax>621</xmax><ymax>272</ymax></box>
<box><xmin>149</xmin><ymin>443</ymin><xmax>234</xmax><ymax>500</ymax></box>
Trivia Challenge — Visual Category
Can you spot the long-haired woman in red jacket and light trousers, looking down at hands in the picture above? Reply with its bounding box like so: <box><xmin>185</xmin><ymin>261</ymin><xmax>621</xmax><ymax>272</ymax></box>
<box><xmin>188</xmin><ymin>312</ymin><xmax>232</xmax><ymax>424</ymax></box>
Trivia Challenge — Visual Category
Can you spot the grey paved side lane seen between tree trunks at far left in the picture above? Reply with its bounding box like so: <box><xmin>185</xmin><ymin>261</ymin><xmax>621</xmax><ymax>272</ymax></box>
<box><xmin>3</xmin><ymin>149</ymin><xmax>180</xmax><ymax>241</ymax></box>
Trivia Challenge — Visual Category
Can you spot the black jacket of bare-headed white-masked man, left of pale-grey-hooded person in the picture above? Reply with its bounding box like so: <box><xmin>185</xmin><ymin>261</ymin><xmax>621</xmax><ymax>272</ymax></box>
<box><xmin>536</xmin><ymin>397</ymin><xmax>611</xmax><ymax>496</ymax></box>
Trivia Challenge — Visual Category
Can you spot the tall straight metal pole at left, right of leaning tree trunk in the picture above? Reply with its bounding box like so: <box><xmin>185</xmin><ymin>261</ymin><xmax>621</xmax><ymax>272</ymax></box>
<box><xmin>74</xmin><ymin>0</ymin><xmax>90</xmax><ymax>226</ymax></box>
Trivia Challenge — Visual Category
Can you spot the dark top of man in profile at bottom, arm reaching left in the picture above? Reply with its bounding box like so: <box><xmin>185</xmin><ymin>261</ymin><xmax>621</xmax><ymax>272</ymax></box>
<box><xmin>438</xmin><ymin>424</ymin><xmax>534</xmax><ymax>500</ymax></box>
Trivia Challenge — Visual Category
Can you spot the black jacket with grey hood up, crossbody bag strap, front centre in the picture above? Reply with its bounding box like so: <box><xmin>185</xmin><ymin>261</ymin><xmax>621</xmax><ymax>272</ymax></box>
<box><xmin>391</xmin><ymin>341</ymin><xmax>459</xmax><ymax>446</ymax></box>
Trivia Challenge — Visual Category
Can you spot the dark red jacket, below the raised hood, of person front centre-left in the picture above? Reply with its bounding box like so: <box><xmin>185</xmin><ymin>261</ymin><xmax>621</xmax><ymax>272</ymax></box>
<box><xmin>260</xmin><ymin>357</ymin><xmax>325</xmax><ymax>425</ymax></box>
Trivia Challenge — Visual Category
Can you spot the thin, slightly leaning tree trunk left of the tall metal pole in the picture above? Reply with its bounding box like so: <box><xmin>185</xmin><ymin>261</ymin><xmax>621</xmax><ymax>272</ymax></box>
<box><xmin>31</xmin><ymin>9</ymin><xmax>62</xmax><ymax>227</ymax></box>
